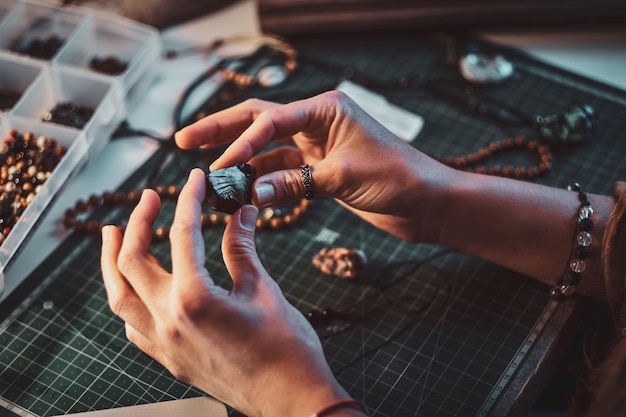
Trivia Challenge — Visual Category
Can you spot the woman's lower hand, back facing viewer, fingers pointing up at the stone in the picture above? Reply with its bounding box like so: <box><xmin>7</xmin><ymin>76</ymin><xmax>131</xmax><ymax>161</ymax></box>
<box><xmin>101</xmin><ymin>169</ymin><xmax>348</xmax><ymax>416</ymax></box>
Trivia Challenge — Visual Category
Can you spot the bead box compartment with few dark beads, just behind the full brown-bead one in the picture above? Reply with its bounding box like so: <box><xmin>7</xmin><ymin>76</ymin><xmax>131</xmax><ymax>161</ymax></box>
<box><xmin>11</xmin><ymin>66</ymin><xmax>125</xmax><ymax>154</ymax></box>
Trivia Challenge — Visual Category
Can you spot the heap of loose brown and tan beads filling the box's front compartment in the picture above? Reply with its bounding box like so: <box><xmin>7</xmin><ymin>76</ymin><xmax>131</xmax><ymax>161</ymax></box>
<box><xmin>0</xmin><ymin>130</ymin><xmax>67</xmax><ymax>244</ymax></box>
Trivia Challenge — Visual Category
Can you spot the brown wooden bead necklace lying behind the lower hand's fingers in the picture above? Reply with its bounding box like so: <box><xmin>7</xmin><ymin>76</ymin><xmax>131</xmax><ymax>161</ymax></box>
<box><xmin>63</xmin><ymin>185</ymin><xmax>311</xmax><ymax>241</ymax></box>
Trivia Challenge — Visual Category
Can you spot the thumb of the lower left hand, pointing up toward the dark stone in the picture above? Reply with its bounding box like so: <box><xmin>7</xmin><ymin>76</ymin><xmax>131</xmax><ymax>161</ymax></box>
<box><xmin>222</xmin><ymin>205</ymin><xmax>267</xmax><ymax>294</ymax></box>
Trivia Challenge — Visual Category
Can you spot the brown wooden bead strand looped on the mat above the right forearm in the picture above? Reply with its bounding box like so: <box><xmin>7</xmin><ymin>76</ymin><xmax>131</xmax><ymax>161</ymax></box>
<box><xmin>440</xmin><ymin>136</ymin><xmax>553</xmax><ymax>180</ymax></box>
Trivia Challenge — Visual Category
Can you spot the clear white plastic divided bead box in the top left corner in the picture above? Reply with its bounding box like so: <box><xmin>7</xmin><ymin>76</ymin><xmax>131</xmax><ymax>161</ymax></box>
<box><xmin>0</xmin><ymin>0</ymin><xmax>161</xmax><ymax>274</ymax></box>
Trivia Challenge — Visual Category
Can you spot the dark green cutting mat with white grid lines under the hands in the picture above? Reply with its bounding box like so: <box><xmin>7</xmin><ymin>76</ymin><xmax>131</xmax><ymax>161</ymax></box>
<box><xmin>0</xmin><ymin>35</ymin><xmax>626</xmax><ymax>416</ymax></box>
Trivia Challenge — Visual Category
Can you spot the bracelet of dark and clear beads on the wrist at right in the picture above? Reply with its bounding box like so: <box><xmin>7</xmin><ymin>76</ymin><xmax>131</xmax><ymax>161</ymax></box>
<box><xmin>550</xmin><ymin>183</ymin><xmax>593</xmax><ymax>300</ymax></box>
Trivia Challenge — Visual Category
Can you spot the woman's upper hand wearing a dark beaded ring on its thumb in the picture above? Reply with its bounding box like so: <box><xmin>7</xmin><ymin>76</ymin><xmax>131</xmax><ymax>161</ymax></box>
<box><xmin>176</xmin><ymin>91</ymin><xmax>454</xmax><ymax>241</ymax></box>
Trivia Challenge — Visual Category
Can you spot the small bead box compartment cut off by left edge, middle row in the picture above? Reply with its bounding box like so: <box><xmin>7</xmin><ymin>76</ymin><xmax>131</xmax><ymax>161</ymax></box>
<box><xmin>0</xmin><ymin>55</ymin><xmax>43</xmax><ymax>113</ymax></box>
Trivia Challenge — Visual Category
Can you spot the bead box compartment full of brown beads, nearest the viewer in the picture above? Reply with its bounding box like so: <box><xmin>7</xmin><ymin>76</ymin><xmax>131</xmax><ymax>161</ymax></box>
<box><xmin>0</xmin><ymin>114</ymin><xmax>89</xmax><ymax>271</ymax></box>
